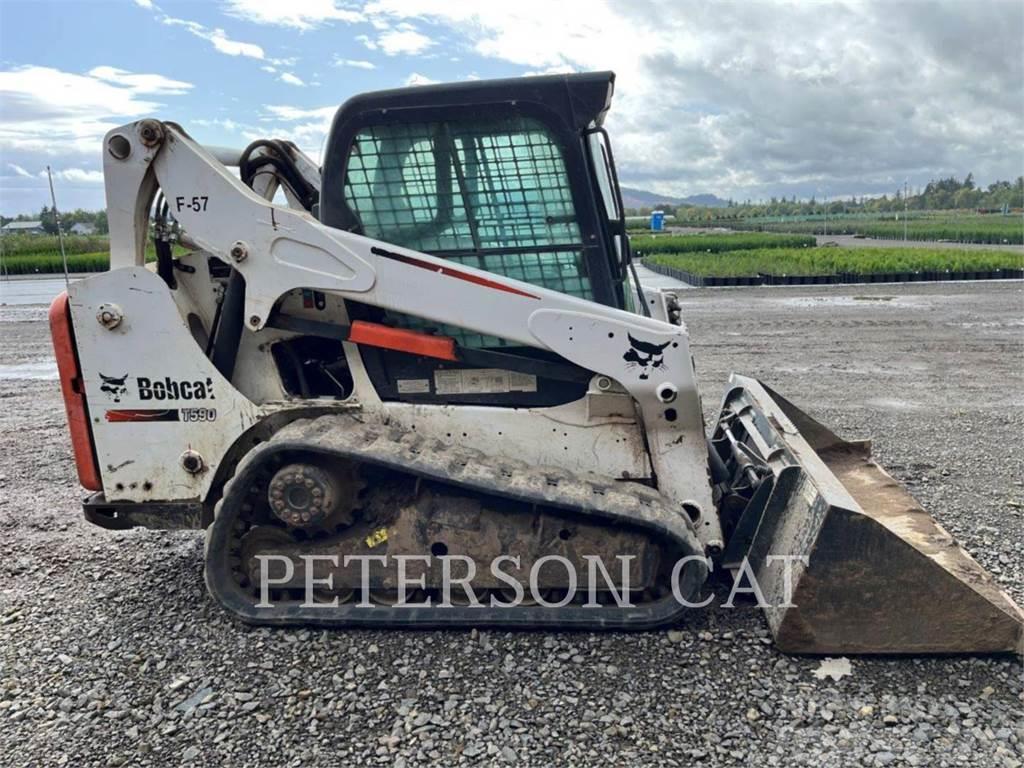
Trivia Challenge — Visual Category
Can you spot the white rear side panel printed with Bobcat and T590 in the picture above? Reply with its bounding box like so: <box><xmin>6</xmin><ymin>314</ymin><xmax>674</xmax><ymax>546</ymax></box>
<box><xmin>69</xmin><ymin>267</ymin><xmax>260</xmax><ymax>501</ymax></box>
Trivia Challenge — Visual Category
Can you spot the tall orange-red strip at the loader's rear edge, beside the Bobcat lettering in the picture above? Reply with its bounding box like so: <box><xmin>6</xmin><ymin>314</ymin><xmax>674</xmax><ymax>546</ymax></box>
<box><xmin>50</xmin><ymin>292</ymin><xmax>103</xmax><ymax>490</ymax></box>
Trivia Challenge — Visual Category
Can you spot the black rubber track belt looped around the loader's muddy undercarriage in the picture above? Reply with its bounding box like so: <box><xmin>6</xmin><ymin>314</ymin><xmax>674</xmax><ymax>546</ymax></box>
<box><xmin>206</xmin><ymin>414</ymin><xmax>707</xmax><ymax>630</ymax></box>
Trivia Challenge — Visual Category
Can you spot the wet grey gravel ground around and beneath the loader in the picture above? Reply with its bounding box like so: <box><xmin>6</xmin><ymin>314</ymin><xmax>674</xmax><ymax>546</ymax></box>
<box><xmin>0</xmin><ymin>283</ymin><xmax>1024</xmax><ymax>766</ymax></box>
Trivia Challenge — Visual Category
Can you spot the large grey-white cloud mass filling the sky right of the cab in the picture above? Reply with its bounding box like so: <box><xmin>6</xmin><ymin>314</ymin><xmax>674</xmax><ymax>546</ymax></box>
<box><xmin>354</xmin><ymin>0</ymin><xmax>1024</xmax><ymax>198</ymax></box>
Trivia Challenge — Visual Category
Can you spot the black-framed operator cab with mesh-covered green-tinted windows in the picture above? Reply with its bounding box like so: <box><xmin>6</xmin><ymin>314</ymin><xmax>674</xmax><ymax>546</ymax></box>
<box><xmin>318</xmin><ymin>72</ymin><xmax>639</xmax><ymax>406</ymax></box>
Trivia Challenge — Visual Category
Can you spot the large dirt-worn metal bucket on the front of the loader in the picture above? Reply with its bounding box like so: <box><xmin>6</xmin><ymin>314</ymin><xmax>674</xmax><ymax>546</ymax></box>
<box><xmin>711</xmin><ymin>374</ymin><xmax>1024</xmax><ymax>654</ymax></box>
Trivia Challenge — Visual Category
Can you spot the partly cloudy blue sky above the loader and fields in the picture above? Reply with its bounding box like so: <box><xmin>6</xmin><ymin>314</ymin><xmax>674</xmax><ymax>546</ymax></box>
<box><xmin>0</xmin><ymin>0</ymin><xmax>1024</xmax><ymax>215</ymax></box>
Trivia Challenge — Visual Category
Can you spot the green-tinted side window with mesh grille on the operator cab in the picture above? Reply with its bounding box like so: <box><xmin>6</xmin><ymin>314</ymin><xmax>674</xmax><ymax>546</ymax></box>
<box><xmin>344</xmin><ymin>117</ymin><xmax>593</xmax><ymax>346</ymax></box>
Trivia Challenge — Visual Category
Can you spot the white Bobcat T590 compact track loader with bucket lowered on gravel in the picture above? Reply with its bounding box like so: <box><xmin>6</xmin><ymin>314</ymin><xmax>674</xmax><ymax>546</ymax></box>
<box><xmin>50</xmin><ymin>73</ymin><xmax>1022</xmax><ymax>653</ymax></box>
